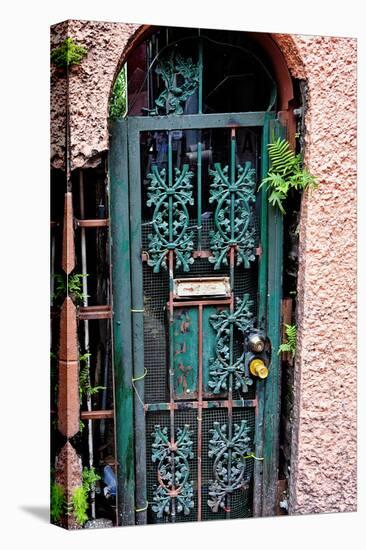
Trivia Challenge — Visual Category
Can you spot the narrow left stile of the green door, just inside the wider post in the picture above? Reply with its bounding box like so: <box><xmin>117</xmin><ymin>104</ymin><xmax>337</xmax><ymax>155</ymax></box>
<box><xmin>128</xmin><ymin>119</ymin><xmax>147</xmax><ymax>525</ymax></box>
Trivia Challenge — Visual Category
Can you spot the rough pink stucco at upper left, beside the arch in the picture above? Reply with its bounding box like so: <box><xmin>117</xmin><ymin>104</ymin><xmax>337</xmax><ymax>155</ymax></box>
<box><xmin>51</xmin><ymin>20</ymin><xmax>139</xmax><ymax>169</ymax></box>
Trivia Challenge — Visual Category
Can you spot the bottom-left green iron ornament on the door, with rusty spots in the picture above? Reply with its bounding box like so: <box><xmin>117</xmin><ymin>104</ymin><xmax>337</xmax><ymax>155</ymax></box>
<box><xmin>151</xmin><ymin>424</ymin><xmax>194</xmax><ymax>518</ymax></box>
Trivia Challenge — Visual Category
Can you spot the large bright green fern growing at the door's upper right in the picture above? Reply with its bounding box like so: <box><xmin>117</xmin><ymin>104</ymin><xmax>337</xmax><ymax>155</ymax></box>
<box><xmin>259</xmin><ymin>138</ymin><xmax>318</xmax><ymax>214</ymax></box>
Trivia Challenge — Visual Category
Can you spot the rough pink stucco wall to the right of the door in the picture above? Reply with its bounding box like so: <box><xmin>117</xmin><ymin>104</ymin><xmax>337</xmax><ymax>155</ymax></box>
<box><xmin>286</xmin><ymin>36</ymin><xmax>357</xmax><ymax>513</ymax></box>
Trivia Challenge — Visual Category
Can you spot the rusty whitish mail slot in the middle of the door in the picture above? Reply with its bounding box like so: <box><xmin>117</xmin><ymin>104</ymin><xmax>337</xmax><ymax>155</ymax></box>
<box><xmin>174</xmin><ymin>277</ymin><xmax>231</xmax><ymax>300</ymax></box>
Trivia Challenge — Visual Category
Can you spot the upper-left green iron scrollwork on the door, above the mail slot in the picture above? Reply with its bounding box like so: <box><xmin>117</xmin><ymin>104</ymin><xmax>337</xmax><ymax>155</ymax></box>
<box><xmin>147</xmin><ymin>164</ymin><xmax>194</xmax><ymax>273</ymax></box>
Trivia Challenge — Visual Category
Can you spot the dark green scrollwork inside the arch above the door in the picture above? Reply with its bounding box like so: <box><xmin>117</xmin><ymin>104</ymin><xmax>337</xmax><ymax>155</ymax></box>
<box><xmin>149</xmin><ymin>50</ymin><xmax>200</xmax><ymax>115</ymax></box>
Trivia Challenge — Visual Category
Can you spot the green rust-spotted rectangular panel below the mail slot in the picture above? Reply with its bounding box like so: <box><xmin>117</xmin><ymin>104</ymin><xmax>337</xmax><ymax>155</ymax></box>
<box><xmin>173</xmin><ymin>307</ymin><xmax>198</xmax><ymax>399</ymax></box>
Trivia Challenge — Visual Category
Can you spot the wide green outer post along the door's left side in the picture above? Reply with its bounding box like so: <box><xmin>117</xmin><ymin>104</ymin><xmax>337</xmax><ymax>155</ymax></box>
<box><xmin>109</xmin><ymin>120</ymin><xmax>135</xmax><ymax>525</ymax></box>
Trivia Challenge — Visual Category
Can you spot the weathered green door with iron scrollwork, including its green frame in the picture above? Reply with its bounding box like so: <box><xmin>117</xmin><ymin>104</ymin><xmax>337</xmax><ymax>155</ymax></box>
<box><xmin>110</xmin><ymin>36</ymin><xmax>282</xmax><ymax>524</ymax></box>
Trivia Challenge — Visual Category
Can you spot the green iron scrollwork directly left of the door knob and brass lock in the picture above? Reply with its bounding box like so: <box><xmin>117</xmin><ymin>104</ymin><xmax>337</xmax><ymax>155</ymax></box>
<box><xmin>208</xmin><ymin>294</ymin><xmax>254</xmax><ymax>394</ymax></box>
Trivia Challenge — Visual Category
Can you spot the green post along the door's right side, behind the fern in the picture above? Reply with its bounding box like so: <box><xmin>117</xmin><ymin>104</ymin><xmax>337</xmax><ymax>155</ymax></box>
<box><xmin>262</xmin><ymin>116</ymin><xmax>286</xmax><ymax>516</ymax></box>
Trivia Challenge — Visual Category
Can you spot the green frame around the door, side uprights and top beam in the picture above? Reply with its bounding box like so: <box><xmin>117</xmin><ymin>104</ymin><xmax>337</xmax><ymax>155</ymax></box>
<box><xmin>109</xmin><ymin>112</ymin><xmax>285</xmax><ymax>525</ymax></box>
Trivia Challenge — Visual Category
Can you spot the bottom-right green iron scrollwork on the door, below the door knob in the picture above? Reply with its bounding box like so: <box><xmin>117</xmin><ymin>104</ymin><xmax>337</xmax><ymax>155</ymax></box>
<box><xmin>207</xmin><ymin>420</ymin><xmax>251</xmax><ymax>512</ymax></box>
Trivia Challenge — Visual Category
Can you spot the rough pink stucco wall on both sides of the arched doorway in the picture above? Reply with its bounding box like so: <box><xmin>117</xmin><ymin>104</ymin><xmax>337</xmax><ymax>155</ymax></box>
<box><xmin>52</xmin><ymin>21</ymin><xmax>356</xmax><ymax>513</ymax></box>
